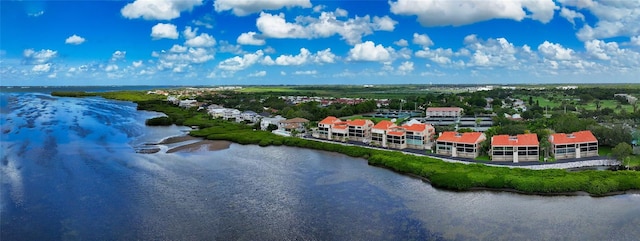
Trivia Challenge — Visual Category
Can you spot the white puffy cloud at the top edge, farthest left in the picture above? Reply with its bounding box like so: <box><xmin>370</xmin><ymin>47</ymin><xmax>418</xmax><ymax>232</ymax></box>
<box><xmin>120</xmin><ymin>0</ymin><xmax>202</xmax><ymax>20</ymax></box>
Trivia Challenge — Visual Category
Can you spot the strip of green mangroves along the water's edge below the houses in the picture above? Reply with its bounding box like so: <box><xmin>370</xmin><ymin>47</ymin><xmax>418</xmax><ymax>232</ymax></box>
<box><xmin>82</xmin><ymin>92</ymin><xmax>640</xmax><ymax>196</ymax></box>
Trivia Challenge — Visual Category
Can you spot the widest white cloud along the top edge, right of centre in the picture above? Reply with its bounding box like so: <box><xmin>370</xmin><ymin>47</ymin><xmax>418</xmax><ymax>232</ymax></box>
<box><xmin>389</xmin><ymin>0</ymin><xmax>557</xmax><ymax>26</ymax></box>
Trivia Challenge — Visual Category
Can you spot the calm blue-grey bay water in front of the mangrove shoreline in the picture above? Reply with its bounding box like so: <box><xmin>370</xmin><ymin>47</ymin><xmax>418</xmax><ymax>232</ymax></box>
<box><xmin>0</xmin><ymin>92</ymin><xmax>640</xmax><ymax>240</ymax></box>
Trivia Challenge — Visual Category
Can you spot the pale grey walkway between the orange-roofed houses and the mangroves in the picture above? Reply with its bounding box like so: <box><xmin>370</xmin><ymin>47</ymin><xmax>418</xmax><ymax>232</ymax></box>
<box><xmin>302</xmin><ymin>137</ymin><xmax>621</xmax><ymax>170</ymax></box>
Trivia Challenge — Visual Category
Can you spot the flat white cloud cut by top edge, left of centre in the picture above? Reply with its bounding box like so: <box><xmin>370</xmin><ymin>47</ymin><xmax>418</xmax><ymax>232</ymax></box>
<box><xmin>213</xmin><ymin>0</ymin><xmax>312</xmax><ymax>16</ymax></box>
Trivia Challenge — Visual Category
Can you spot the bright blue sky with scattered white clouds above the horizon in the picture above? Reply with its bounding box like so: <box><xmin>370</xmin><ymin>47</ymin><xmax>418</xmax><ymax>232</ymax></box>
<box><xmin>0</xmin><ymin>0</ymin><xmax>640</xmax><ymax>85</ymax></box>
